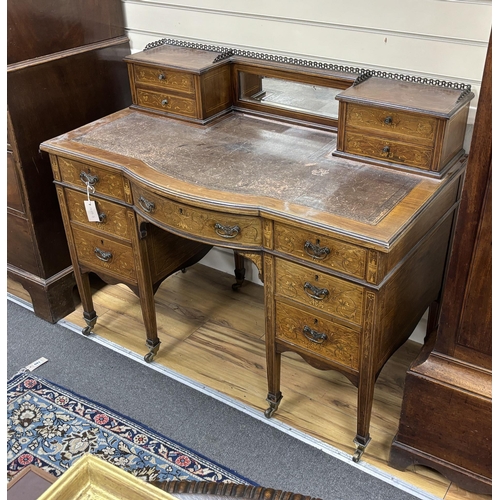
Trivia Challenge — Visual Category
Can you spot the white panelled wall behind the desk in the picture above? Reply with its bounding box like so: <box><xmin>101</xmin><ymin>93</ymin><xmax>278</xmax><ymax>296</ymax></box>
<box><xmin>123</xmin><ymin>0</ymin><xmax>492</xmax><ymax>340</ymax></box>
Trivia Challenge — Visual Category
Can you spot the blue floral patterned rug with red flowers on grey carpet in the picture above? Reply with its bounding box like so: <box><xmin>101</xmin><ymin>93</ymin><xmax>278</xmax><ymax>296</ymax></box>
<box><xmin>7</xmin><ymin>373</ymin><xmax>255</xmax><ymax>485</ymax></box>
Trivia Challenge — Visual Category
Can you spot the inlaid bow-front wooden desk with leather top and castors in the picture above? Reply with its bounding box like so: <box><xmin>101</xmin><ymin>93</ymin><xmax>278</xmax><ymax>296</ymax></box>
<box><xmin>41</xmin><ymin>43</ymin><xmax>470</xmax><ymax>461</ymax></box>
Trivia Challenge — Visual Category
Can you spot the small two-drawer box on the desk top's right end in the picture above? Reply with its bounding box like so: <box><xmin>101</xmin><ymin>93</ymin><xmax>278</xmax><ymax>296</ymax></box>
<box><xmin>334</xmin><ymin>77</ymin><xmax>473</xmax><ymax>177</ymax></box>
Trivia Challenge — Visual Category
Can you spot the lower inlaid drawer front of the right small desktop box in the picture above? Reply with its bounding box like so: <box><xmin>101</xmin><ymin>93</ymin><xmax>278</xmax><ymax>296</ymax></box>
<box><xmin>345</xmin><ymin>132</ymin><xmax>433</xmax><ymax>170</ymax></box>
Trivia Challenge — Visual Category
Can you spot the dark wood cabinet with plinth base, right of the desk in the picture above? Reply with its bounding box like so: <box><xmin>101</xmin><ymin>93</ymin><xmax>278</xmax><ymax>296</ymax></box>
<box><xmin>390</xmin><ymin>33</ymin><xmax>492</xmax><ymax>494</ymax></box>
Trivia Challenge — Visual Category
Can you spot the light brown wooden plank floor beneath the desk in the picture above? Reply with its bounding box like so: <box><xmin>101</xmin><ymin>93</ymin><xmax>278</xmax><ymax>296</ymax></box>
<box><xmin>8</xmin><ymin>264</ymin><xmax>491</xmax><ymax>500</ymax></box>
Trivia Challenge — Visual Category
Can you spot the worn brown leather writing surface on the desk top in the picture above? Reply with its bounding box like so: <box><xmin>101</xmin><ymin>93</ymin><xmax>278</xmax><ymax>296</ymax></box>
<box><xmin>75</xmin><ymin>113</ymin><xmax>421</xmax><ymax>225</ymax></box>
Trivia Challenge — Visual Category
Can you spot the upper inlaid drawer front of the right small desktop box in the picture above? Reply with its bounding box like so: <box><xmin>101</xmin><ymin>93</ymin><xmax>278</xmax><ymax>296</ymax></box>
<box><xmin>347</xmin><ymin>104</ymin><xmax>438</xmax><ymax>146</ymax></box>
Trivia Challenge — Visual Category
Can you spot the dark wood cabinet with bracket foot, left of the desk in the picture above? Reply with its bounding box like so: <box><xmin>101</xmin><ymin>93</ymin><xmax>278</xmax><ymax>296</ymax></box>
<box><xmin>7</xmin><ymin>0</ymin><xmax>131</xmax><ymax>323</ymax></box>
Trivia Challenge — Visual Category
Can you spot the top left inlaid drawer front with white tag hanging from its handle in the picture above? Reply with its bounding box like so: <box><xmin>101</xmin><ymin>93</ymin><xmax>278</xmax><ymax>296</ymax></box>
<box><xmin>58</xmin><ymin>157</ymin><xmax>126</xmax><ymax>201</ymax></box>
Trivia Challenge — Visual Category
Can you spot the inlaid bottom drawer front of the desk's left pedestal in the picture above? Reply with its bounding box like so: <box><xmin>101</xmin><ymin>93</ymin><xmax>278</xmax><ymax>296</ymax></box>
<box><xmin>73</xmin><ymin>228</ymin><xmax>136</xmax><ymax>282</ymax></box>
